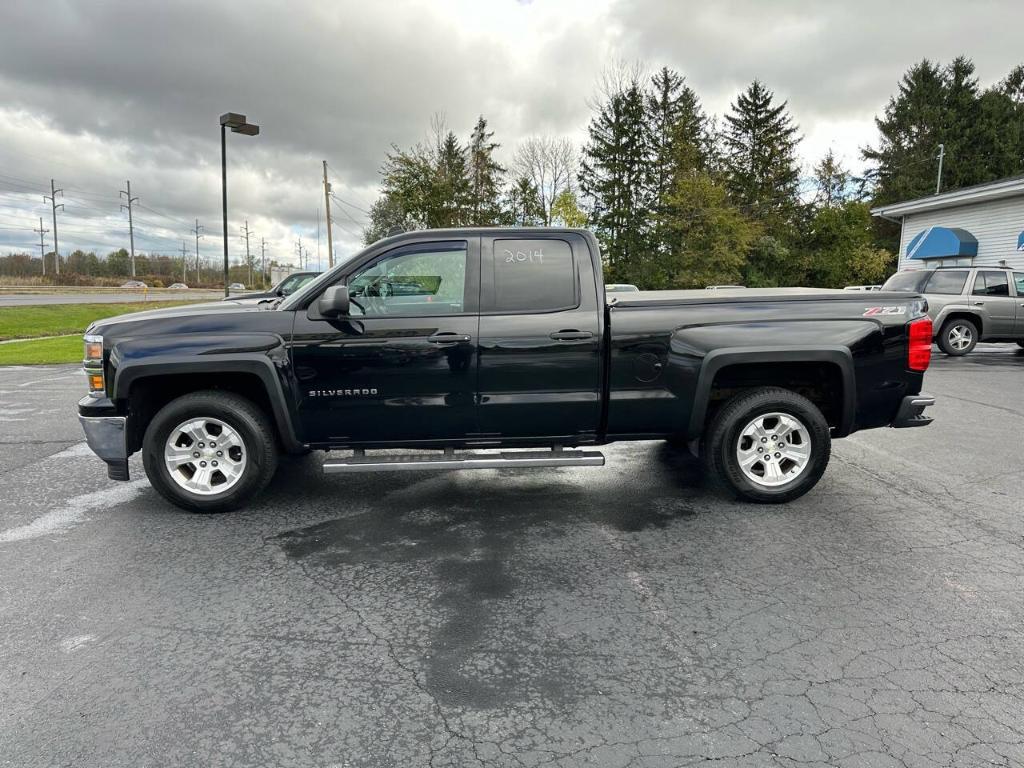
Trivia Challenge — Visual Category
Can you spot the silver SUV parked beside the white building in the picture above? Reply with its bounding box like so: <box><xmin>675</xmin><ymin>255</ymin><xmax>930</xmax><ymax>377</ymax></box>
<box><xmin>882</xmin><ymin>266</ymin><xmax>1024</xmax><ymax>355</ymax></box>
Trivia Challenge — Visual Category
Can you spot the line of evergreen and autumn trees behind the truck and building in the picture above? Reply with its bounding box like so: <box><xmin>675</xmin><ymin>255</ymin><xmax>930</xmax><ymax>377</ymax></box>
<box><xmin>364</xmin><ymin>56</ymin><xmax>1024</xmax><ymax>289</ymax></box>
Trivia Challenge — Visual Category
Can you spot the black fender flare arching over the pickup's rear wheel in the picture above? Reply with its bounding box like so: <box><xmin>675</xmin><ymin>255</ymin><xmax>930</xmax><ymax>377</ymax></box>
<box><xmin>687</xmin><ymin>346</ymin><xmax>857</xmax><ymax>440</ymax></box>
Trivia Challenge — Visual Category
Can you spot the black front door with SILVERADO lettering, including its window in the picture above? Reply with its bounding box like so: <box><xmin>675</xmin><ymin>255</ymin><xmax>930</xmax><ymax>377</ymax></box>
<box><xmin>292</xmin><ymin>238</ymin><xmax>480</xmax><ymax>445</ymax></box>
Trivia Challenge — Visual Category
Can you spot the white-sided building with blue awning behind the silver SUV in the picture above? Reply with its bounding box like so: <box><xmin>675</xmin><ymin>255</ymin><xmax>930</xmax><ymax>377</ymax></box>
<box><xmin>871</xmin><ymin>176</ymin><xmax>1024</xmax><ymax>270</ymax></box>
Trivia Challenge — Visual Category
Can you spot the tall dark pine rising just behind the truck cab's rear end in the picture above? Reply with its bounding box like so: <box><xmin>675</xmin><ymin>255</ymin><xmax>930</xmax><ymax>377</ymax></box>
<box><xmin>580</xmin><ymin>71</ymin><xmax>651</xmax><ymax>282</ymax></box>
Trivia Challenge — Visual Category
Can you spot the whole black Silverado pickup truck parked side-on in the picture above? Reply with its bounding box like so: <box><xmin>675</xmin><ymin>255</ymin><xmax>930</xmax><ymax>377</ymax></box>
<box><xmin>79</xmin><ymin>228</ymin><xmax>934</xmax><ymax>512</ymax></box>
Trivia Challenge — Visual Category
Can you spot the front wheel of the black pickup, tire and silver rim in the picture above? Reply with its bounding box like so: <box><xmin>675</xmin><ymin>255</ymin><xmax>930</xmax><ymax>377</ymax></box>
<box><xmin>142</xmin><ymin>390</ymin><xmax>278</xmax><ymax>512</ymax></box>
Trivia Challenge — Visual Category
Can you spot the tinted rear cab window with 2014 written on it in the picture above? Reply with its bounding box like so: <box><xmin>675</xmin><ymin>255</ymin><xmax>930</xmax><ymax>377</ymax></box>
<box><xmin>494</xmin><ymin>240</ymin><xmax>579</xmax><ymax>312</ymax></box>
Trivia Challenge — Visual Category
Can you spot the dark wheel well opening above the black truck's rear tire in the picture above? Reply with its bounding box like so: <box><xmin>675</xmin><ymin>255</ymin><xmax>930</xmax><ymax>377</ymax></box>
<box><xmin>706</xmin><ymin>362</ymin><xmax>844</xmax><ymax>427</ymax></box>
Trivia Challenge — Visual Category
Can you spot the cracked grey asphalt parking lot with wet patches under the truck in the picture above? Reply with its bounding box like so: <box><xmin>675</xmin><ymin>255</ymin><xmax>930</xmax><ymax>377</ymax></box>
<box><xmin>0</xmin><ymin>345</ymin><xmax>1024</xmax><ymax>768</ymax></box>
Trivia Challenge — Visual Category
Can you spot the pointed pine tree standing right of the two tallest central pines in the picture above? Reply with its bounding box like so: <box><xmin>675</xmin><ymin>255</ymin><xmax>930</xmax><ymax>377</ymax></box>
<box><xmin>722</xmin><ymin>80</ymin><xmax>800</xmax><ymax>230</ymax></box>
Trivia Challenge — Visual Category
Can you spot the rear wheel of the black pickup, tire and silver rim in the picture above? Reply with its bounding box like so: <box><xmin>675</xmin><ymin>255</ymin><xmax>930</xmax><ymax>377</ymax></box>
<box><xmin>702</xmin><ymin>387</ymin><xmax>831</xmax><ymax>504</ymax></box>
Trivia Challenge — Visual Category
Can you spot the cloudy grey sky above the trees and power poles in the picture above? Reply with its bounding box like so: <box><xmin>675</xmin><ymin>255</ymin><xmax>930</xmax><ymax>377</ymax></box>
<box><xmin>0</xmin><ymin>0</ymin><xmax>1024</xmax><ymax>265</ymax></box>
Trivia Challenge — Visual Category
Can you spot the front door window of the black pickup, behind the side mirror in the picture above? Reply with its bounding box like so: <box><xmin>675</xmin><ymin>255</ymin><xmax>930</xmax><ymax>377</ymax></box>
<box><xmin>348</xmin><ymin>244</ymin><xmax>468</xmax><ymax>315</ymax></box>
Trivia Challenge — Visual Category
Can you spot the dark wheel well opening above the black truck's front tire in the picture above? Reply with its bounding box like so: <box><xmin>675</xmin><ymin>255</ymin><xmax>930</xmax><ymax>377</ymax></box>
<box><xmin>128</xmin><ymin>373</ymin><xmax>281</xmax><ymax>453</ymax></box>
